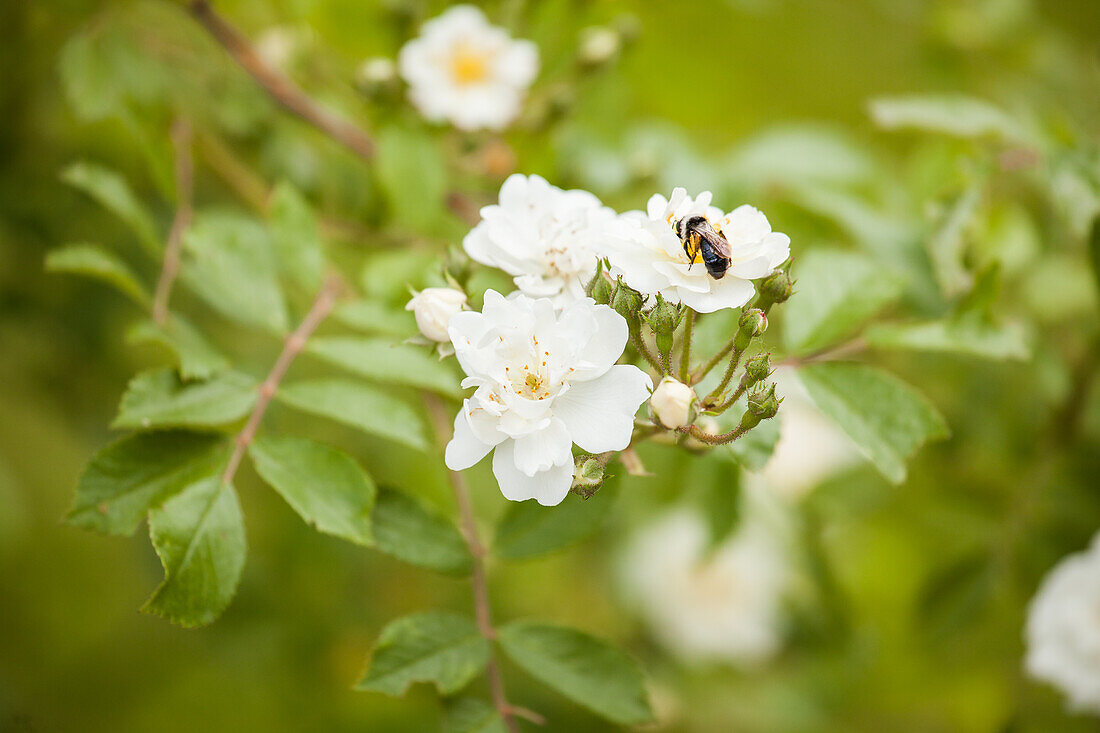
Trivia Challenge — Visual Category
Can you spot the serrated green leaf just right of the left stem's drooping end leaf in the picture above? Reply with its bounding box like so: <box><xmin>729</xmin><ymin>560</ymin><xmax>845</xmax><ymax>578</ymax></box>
<box><xmin>249</xmin><ymin>436</ymin><xmax>375</xmax><ymax>546</ymax></box>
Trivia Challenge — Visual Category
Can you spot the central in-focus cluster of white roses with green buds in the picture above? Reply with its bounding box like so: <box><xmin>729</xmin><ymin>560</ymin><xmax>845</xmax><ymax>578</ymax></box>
<box><xmin>408</xmin><ymin>174</ymin><xmax>790</xmax><ymax>504</ymax></box>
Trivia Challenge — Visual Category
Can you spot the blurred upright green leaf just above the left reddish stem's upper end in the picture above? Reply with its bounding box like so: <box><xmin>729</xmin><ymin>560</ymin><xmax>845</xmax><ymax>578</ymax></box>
<box><xmin>271</xmin><ymin>182</ymin><xmax>325</xmax><ymax>294</ymax></box>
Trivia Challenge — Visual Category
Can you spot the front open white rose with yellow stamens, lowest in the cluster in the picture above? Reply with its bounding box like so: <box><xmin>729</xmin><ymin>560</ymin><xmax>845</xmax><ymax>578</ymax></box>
<box><xmin>446</xmin><ymin>291</ymin><xmax>652</xmax><ymax>506</ymax></box>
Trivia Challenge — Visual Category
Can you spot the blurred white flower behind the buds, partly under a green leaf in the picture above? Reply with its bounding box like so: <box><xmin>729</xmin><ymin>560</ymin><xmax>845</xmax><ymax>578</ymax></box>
<box><xmin>761</xmin><ymin>367</ymin><xmax>862</xmax><ymax>499</ymax></box>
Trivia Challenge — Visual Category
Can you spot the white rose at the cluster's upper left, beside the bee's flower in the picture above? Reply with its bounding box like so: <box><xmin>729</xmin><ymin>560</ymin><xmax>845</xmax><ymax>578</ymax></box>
<box><xmin>462</xmin><ymin>174</ymin><xmax>616</xmax><ymax>307</ymax></box>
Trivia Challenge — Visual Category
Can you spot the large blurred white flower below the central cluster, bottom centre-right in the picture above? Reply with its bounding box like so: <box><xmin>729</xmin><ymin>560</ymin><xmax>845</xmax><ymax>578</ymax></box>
<box><xmin>620</xmin><ymin>510</ymin><xmax>791</xmax><ymax>665</ymax></box>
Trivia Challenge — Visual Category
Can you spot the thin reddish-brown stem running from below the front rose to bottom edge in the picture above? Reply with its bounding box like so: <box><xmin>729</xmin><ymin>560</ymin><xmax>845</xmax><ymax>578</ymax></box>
<box><xmin>425</xmin><ymin>394</ymin><xmax>525</xmax><ymax>733</ymax></box>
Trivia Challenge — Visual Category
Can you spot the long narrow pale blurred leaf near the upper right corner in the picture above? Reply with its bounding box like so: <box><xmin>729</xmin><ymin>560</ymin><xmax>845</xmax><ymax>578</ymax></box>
<box><xmin>870</xmin><ymin>95</ymin><xmax>1036</xmax><ymax>145</ymax></box>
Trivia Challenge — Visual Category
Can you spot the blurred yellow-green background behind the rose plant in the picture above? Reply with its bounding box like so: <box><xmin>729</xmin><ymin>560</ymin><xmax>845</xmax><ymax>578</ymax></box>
<box><xmin>0</xmin><ymin>0</ymin><xmax>1100</xmax><ymax>732</ymax></box>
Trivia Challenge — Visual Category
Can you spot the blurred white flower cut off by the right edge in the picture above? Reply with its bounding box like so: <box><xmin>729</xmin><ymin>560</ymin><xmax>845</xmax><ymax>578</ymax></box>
<box><xmin>1024</xmin><ymin>534</ymin><xmax>1100</xmax><ymax>714</ymax></box>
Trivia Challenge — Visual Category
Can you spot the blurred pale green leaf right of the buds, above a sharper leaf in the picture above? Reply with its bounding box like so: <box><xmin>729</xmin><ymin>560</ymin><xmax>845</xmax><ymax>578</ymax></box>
<box><xmin>783</xmin><ymin>250</ymin><xmax>901</xmax><ymax>353</ymax></box>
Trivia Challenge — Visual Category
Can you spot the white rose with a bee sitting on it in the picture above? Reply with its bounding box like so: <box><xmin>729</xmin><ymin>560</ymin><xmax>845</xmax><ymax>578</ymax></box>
<box><xmin>606</xmin><ymin>188</ymin><xmax>791</xmax><ymax>313</ymax></box>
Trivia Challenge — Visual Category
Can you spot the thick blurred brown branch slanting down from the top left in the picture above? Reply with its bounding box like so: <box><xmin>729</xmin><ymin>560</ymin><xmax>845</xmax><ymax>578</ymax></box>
<box><xmin>187</xmin><ymin>0</ymin><xmax>374</xmax><ymax>160</ymax></box>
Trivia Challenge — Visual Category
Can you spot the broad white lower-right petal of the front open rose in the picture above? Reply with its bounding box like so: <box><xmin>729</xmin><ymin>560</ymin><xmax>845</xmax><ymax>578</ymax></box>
<box><xmin>553</xmin><ymin>364</ymin><xmax>653</xmax><ymax>453</ymax></box>
